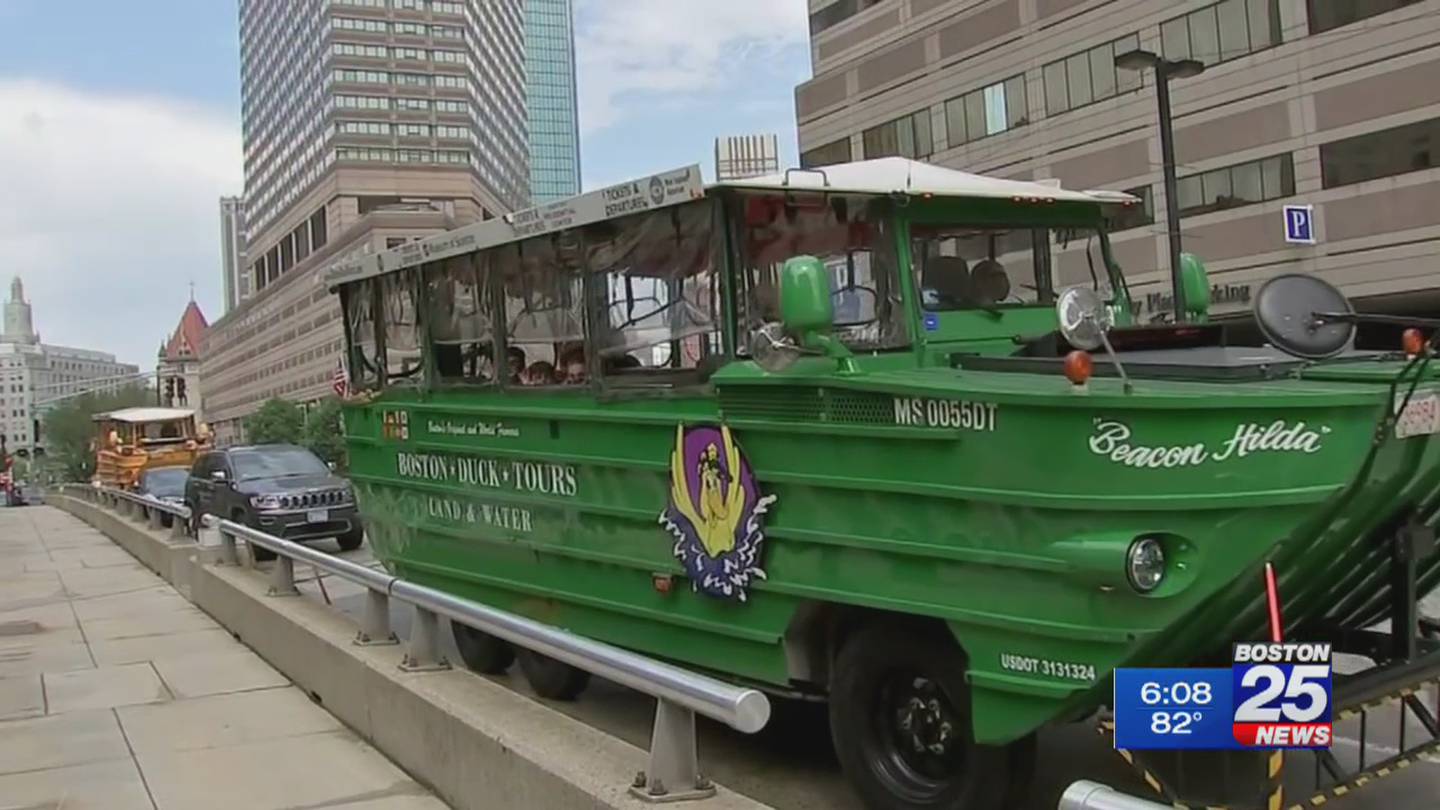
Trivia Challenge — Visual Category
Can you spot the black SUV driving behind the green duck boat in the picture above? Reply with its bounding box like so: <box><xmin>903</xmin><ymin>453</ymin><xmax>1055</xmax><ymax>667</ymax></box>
<box><xmin>184</xmin><ymin>444</ymin><xmax>364</xmax><ymax>559</ymax></box>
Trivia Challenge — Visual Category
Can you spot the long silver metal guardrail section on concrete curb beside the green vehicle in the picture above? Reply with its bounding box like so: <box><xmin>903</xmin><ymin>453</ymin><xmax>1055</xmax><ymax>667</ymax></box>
<box><xmin>202</xmin><ymin>515</ymin><xmax>770</xmax><ymax>801</ymax></box>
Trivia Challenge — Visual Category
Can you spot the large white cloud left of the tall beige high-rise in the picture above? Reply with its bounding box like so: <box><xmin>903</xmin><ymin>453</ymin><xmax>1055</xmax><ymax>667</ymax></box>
<box><xmin>0</xmin><ymin>79</ymin><xmax>242</xmax><ymax>368</ymax></box>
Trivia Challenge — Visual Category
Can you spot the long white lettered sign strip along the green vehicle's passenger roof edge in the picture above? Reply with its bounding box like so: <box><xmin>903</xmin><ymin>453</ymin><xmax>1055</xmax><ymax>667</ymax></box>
<box><xmin>324</xmin><ymin>163</ymin><xmax>706</xmax><ymax>287</ymax></box>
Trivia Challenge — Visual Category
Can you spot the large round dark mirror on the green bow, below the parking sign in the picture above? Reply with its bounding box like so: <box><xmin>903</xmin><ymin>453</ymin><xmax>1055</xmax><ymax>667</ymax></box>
<box><xmin>1254</xmin><ymin>272</ymin><xmax>1355</xmax><ymax>360</ymax></box>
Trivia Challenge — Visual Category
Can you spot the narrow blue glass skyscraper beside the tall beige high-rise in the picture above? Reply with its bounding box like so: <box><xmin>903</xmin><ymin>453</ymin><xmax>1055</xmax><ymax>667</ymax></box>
<box><xmin>526</xmin><ymin>0</ymin><xmax>580</xmax><ymax>203</ymax></box>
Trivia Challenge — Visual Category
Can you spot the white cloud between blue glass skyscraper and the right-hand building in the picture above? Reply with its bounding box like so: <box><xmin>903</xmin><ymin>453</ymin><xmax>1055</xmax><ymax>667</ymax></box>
<box><xmin>576</xmin><ymin>0</ymin><xmax>806</xmax><ymax>133</ymax></box>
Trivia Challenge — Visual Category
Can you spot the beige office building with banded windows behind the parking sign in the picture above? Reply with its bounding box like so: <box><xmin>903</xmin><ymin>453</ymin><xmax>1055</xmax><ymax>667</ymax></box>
<box><xmin>795</xmin><ymin>0</ymin><xmax>1440</xmax><ymax>319</ymax></box>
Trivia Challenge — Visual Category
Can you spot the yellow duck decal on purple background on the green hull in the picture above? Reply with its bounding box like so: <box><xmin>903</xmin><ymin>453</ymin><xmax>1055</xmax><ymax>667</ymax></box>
<box><xmin>660</xmin><ymin>425</ymin><xmax>775</xmax><ymax>602</ymax></box>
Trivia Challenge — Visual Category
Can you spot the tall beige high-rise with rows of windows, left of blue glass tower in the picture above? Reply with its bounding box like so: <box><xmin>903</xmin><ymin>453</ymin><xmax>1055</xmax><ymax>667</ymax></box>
<box><xmin>202</xmin><ymin>0</ymin><xmax>530</xmax><ymax>441</ymax></box>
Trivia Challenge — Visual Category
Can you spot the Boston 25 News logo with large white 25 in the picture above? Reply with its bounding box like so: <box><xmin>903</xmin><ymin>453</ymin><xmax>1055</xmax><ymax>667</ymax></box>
<box><xmin>1231</xmin><ymin>643</ymin><xmax>1332</xmax><ymax>748</ymax></box>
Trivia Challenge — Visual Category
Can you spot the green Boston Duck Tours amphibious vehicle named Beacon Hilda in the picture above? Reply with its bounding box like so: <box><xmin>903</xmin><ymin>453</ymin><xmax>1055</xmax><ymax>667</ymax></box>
<box><xmin>327</xmin><ymin>159</ymin><xmax>1440</xmax><ymax>810</ymax></box>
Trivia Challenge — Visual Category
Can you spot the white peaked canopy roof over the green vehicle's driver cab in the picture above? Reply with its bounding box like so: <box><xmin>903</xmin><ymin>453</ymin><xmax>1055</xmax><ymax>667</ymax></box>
<box><xmin>716</xmin><ymin>157</ymin><xmax>1140</xmax><ymax>203</ymax></box>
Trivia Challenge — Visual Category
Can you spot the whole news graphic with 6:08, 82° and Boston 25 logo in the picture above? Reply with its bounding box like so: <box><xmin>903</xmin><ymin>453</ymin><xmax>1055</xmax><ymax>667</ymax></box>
<box><xmin>1115</xmin><ymin>643</ymin><xmax>1332</xmax><ymax>751</ymax></box>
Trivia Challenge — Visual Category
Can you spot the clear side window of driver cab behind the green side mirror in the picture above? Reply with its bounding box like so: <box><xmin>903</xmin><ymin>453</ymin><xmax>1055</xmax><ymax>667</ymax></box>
<box><xmin>736</xmin><ymin>195</ymin><xmax>909</xmax><ymax>353</ymax></box>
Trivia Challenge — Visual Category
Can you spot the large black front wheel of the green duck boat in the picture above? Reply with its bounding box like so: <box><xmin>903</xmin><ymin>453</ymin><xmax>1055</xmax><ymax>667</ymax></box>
<box><xmin>829</xmin><ymin>623</ymin><xmax>1024</xmax><ymax>810</ymax></box>
